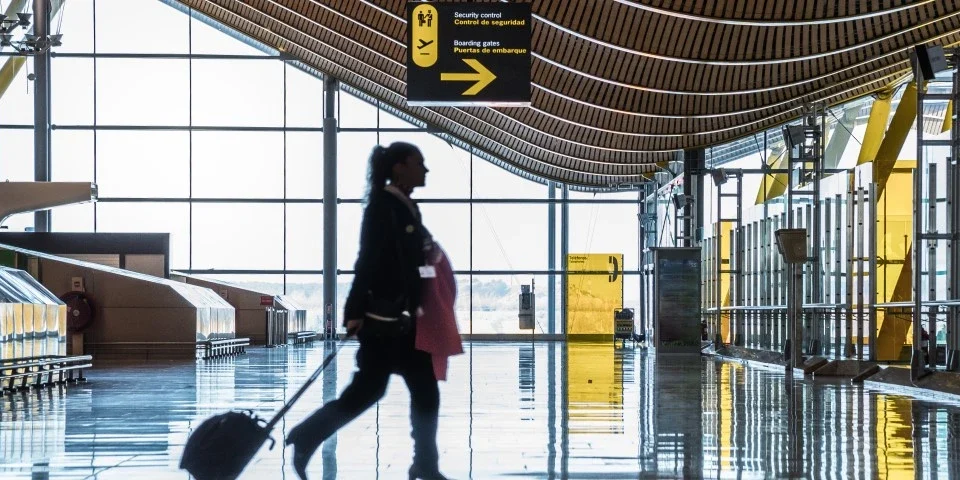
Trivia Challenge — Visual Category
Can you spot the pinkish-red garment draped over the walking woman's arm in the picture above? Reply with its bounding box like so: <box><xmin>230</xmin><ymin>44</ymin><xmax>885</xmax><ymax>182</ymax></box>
<box><xmin>415</xmin><ymin>243</ymin><xmax>463</xmax><ymax>380</ymax></box>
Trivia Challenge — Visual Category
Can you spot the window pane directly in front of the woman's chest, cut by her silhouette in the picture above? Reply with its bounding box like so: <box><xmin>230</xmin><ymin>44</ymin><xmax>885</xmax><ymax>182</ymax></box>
<box><xmin>420</xmin><ymin>203</ymin><xmax>470</xmax><ymax>270</ymax></box>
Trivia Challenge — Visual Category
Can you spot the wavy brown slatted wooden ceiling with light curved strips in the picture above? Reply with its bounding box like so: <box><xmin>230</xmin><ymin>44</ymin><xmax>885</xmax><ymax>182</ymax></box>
<box><xmin>172</xmin><ymin>0</ymin><xmax>960</xmax><ymax>186</ymax></box>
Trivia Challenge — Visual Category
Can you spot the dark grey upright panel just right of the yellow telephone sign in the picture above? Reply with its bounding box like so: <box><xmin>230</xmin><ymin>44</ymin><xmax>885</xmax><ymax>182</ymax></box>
<box><xmin>653</xmin><ymin>248</ymin><xmax>702</xmax><ymax>354</ymax></box>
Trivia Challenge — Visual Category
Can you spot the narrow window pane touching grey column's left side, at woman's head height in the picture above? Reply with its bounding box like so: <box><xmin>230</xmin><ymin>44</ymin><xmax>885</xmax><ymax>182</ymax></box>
<box><xmin>287</xmin><ymin>132</ymin><xmax>323</xmax><ymax>198</ymax></box>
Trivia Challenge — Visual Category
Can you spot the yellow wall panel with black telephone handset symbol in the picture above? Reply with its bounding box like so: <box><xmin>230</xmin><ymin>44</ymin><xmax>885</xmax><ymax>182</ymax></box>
<box><xmin>567</xmin><ymin>253</ymin><xmax>623</xmax><ymax>338</ymax></box>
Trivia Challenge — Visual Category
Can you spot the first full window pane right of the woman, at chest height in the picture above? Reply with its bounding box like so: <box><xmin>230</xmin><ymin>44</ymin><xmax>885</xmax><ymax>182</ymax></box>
<box><xmin>473</xmin><ymin>204</ymin><xmax>548</xmax><ymax>270</ymax></box>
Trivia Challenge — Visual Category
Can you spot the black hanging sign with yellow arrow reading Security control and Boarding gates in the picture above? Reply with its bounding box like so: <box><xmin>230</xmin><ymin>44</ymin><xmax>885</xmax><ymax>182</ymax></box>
<box><xmin>407</xmin><ymin>2</ymin><xmax>530</xmax><ymax>106</ymax></box>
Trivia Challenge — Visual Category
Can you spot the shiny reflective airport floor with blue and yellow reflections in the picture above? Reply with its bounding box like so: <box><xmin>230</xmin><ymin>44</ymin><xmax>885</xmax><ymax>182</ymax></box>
<box><xmin>0</xmin><ymin>343</ymin><xmax>960</xmax><ymax>479</ymax></box>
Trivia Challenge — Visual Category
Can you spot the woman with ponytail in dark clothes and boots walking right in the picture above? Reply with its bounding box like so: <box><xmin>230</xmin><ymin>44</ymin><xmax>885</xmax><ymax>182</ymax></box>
<box><xmin>286</xmin><ymin>142</ymin><xmax>445</xmax><ymax>480</ymax></box>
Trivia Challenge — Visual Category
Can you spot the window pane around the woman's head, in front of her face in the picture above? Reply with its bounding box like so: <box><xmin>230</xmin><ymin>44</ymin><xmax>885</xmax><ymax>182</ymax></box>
<box><xmin>380</xmin><ymin>132</ymin><xmax>470</xmax><ymax>198</ymax></box>
